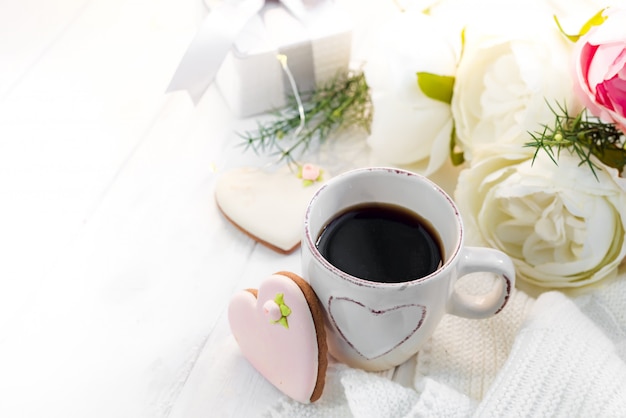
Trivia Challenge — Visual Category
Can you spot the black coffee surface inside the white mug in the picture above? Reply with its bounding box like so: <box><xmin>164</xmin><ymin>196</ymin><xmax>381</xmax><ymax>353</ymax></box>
<box><xmin>316</xmin><ymin>203</ymin><xmax>443</xmax><ymax>283</ymax></box>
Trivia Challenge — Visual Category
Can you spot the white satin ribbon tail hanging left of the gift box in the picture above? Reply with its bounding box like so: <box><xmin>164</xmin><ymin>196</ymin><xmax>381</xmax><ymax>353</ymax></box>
<box><xmin>166</xmin><ymin>0</ymin><xmax>265</xmax><ymax>104</ymax></box>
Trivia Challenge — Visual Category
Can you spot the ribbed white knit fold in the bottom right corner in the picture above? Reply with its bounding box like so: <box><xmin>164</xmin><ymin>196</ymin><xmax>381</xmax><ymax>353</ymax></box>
<box><xmin>476</xmin><ymin>292</ymin><xmax>626</xmax><ymax>417</ymax></box>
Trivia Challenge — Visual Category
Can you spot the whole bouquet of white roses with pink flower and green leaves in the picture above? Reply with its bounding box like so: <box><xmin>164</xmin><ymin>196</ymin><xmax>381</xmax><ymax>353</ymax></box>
<box><xmin>365</xmin><ymin>0</ymin><xmax>626</xmax><ymax>289</ymax></box>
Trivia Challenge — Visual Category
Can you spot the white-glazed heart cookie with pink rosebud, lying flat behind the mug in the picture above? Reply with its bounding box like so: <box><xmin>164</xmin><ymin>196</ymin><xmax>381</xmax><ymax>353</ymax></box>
<box><xmin>215</xmin><ymin>164</ymin><xmax>329</xmax><ymax>254</ymax></box>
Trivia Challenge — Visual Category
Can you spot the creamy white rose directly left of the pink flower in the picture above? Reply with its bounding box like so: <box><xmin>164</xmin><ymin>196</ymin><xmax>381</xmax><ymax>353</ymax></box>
<box><xmin>452</xmin><ymin>16</ymin><xmax>580</xmax><ymax>160</ymax></box>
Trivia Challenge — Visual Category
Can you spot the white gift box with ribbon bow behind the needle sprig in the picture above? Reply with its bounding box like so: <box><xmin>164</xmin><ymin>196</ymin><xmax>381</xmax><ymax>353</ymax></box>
<box><xmin>215</xmin><ymin>1</ymin><xmax>352</xmax><ymax>117</ymax></box>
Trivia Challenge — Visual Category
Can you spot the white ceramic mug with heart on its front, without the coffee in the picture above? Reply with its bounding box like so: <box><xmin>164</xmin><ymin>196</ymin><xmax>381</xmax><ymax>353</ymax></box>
<box><xmin>302</xmin><ymin>167</ymin><xmax>515</xmax><ymax>371</ymax></box>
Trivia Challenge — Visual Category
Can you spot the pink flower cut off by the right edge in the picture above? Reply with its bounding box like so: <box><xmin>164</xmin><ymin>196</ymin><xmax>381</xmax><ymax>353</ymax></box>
<box><xmin>574</xmin><ymin>9</ymin><xmax>626</xmax><ymax>132</ymax></box>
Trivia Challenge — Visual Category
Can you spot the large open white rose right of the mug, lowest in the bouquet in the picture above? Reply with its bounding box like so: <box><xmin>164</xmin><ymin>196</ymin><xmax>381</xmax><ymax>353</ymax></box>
<box><xmin>455</xmin><ymin>146</ymin><xmax>626</xmax><ymax>288</ymax></box>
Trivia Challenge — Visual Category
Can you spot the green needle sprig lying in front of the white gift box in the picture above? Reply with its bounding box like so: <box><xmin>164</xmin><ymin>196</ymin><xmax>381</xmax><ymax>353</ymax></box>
<box><xmin>239</xmin><ymin>70</ymin><xmax>373</xmax><ymax>164</ymax></box>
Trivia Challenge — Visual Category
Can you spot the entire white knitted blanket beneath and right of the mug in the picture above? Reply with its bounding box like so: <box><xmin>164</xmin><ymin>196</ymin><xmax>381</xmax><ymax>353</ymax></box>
<box><xmin>266</xmin><ymin>274</ymin><xmax>626</xmax><ymax>418</ymax></box>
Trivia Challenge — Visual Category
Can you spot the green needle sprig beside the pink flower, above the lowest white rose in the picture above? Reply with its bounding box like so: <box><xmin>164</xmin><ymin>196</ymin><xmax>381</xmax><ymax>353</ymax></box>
<box><xmin>525</xmin><ymin>103</ymin><xmax>626</xmax><ymax>179</ymax></box>
